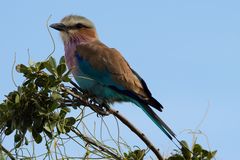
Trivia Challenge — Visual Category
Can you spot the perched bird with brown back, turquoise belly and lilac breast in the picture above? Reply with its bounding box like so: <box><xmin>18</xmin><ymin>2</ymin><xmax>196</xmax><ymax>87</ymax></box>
<box><xmin>50</xmin><ymin>15</ymin><xmax>179</xmax><ymax>142</ymax></box>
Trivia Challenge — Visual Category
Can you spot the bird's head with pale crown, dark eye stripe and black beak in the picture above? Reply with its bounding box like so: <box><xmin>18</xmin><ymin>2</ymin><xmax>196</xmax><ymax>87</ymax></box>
<box><xmin>50</xmin><ymin>15</ymin><xmax>98</xmax><ymax>44</ymax></box>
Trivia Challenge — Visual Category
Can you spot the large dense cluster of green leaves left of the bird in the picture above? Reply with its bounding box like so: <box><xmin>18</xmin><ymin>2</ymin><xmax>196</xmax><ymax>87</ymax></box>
<box><xmin>0</xmin><ymin>57</ymin><xmax>71</xmax><ymax>148</ymax></box>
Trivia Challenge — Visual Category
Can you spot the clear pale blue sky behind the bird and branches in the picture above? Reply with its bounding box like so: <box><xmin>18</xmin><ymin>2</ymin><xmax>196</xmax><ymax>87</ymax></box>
<box><xmin>0</xmin><ymin>0</ymin><xmax>240</xmax><ymax>160</ymax></box>
